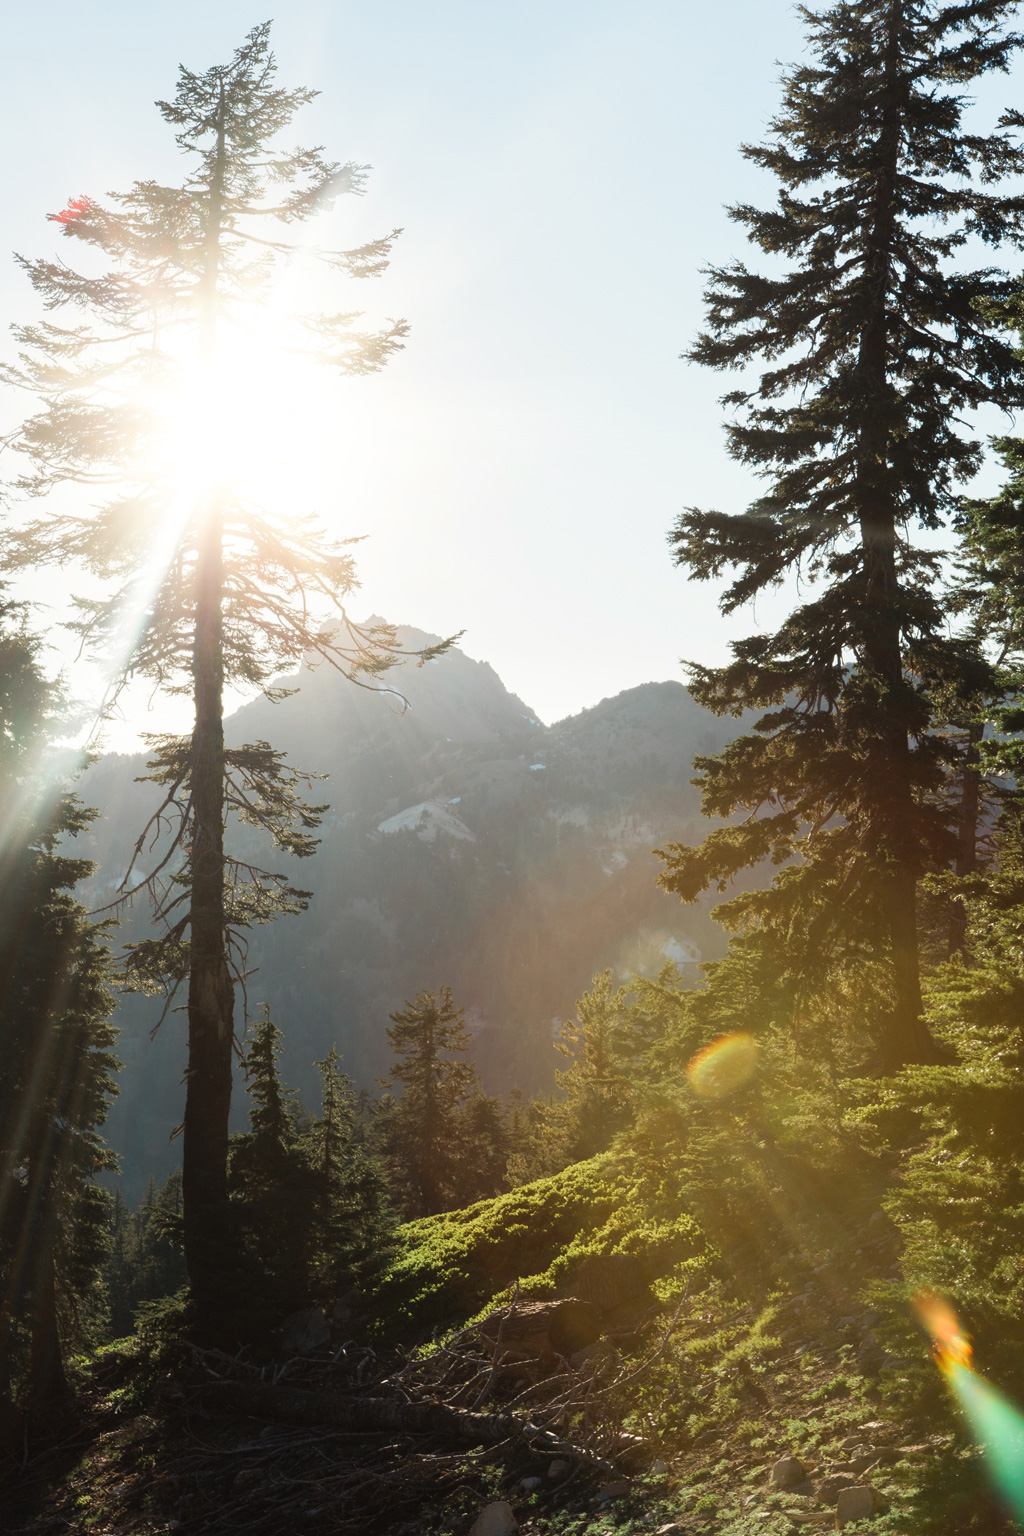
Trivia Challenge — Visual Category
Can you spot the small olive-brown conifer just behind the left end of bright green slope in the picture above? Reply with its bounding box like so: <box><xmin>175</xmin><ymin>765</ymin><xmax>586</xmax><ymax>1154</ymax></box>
<box><xmin>384</xmin><ymin>986</ymin><xmax>479</xmax><ymax>1217</ymax></box>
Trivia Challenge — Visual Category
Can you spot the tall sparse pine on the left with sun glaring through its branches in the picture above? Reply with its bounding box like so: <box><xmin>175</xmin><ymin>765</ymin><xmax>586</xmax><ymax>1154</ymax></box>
<box><xmin>6</xmin><ymin>25</ymin><xmax>448</xmax><ymax>1327</ymax></box>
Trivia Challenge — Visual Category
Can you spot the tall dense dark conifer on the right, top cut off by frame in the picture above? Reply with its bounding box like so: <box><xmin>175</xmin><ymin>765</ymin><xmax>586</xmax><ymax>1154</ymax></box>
<box><xmin>662</xmin><ymin>0</ymin><xmax>1024</xmax><ymax>1069</ymax></box>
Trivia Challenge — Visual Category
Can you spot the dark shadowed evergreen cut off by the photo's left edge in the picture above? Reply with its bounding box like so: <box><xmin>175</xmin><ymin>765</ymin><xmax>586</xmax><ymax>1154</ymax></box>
<box><xmin>0</xmin><ymin>604</ymin><xmax>117</xmax><ymax>1439</ymax></box>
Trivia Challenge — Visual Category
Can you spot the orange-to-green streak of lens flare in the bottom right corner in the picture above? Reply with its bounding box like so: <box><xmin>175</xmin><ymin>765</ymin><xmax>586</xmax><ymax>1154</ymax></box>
<box><xmin>913</xmin><ymin>1290</ymin><xmax>1024</xmax><ymax>1524</ymax></box>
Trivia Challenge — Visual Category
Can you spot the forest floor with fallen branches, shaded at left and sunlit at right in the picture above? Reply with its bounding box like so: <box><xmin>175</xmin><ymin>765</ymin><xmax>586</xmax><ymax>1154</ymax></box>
<box><xmin>3</xmin><ymin>1204</ymin><xmax>1013</xmax><ymax>1536</ymax></box>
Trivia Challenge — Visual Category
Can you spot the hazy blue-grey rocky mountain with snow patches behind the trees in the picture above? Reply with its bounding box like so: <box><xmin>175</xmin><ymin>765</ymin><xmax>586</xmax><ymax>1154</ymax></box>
<box><xmin>75</xmin><ymin>630</ymin><xmax>737</xmax><ymax>1200</ymax></box>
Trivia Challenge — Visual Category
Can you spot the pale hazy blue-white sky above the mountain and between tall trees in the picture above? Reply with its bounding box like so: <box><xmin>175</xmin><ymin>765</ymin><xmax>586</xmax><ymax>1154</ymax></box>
<box><xmin>0</xmin><ymin>0</ymin><xmax>1019</xmax><ymax>737</ymax></box>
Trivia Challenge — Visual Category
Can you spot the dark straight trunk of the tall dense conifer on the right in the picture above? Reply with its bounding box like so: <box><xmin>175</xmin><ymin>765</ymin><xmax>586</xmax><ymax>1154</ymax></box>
<box><xmin>857</xmin><ymin>0</ymin><xmax>938</xmax><ymax>1071</ymax></box>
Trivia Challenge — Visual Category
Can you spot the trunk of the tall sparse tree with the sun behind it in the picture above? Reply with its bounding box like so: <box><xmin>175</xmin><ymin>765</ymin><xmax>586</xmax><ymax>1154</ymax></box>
<box><xmin>181</xmin><ymin>84</ymin><xmax>235</xmax><ymax>1329</ymax></box>
